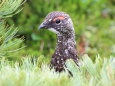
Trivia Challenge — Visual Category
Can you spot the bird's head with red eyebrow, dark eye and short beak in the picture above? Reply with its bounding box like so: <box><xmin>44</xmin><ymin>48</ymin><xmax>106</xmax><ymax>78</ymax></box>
<box><xmin>39</xmin><ymin>11</ymin><xmax>74</xmax><ymax>35</ymax></box>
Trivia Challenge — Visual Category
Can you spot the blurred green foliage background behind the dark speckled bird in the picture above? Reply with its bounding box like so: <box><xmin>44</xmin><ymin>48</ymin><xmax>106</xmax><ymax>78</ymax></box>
<box><xmin>7</xmin><ymin>0</ymin><xmax>115</xmax><ymax>59</ymax></box>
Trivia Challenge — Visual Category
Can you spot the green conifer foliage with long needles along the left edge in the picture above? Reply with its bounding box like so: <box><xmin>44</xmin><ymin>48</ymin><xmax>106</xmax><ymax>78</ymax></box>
<box><xmin>0</xmin><ymin>0</ymin><xmax>24</xmax><ymax>57</ymax></box>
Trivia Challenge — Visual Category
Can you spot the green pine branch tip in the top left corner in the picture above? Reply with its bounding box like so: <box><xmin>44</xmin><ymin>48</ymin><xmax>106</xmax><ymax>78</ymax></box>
<box><xmin>0</xmin><ymin>0</ymin><xmax>25</xmax><ymax>19</ymax></box>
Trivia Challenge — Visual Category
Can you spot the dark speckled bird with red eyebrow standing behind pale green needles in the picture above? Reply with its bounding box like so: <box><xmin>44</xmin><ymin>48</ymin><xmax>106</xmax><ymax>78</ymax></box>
<box><xmin>38</xmin><ymin>11</ymin><xmax>79</xmax><ymax>72</ymax></box>
